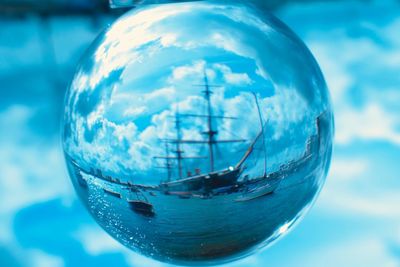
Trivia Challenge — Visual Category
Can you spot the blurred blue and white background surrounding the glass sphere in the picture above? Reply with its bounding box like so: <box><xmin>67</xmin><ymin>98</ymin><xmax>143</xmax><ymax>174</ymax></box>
<box><xmin>0</xmin><ymin>0</ymin><xmax>400</xmax><ymax>267</ymax></box>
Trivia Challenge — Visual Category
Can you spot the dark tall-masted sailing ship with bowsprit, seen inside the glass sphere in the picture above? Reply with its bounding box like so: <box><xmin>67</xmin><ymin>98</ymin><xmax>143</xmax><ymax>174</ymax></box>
<box><xmin>155</xmin><ymin>74</ymin><xmax>266</xmax><ymax>197</ymax></box>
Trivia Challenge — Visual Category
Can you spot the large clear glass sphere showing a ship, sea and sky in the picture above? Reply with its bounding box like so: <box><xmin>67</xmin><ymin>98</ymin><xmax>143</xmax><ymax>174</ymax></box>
<box><xmin>63</xmin><ymin>2</ymin><xmax>333</xmax><ymax>265</ymax></box>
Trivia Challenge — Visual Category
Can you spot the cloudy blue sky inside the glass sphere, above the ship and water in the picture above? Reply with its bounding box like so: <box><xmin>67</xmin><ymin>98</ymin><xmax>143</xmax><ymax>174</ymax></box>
<box><xmin>64</xmin><ymin>2</ymin><xmax>329</xmax><ymax>184</ymax></box>
